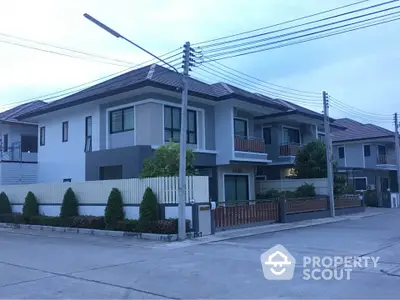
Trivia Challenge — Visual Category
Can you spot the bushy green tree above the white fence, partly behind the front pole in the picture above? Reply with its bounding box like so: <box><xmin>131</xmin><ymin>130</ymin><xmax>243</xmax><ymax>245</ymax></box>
<box><xmin>140</xmin><ymin>142</ymin><xmax>196</xmax><ymax>178</ymax></box>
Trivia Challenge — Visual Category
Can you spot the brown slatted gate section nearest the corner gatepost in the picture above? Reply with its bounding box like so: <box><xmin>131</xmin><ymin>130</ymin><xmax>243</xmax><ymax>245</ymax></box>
<box><xmin>213</xmin><ymin>201</ymin><xmax>279</xmax><ymax>230</ymax></box>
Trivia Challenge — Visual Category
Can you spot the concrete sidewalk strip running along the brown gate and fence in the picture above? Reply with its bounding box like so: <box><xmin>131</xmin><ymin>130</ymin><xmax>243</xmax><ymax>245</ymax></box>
<box><xmin>169</xmin><ymin>207</ymin><xmax>395</xmax><ymax>247</ymax></box>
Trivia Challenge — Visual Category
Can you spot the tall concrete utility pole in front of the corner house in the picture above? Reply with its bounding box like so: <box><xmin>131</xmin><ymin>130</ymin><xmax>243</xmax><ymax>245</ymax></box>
<box><xmin>178</xmin><ymin>42</ymin><xmax>190</xmax><ymax>240</ymax></box>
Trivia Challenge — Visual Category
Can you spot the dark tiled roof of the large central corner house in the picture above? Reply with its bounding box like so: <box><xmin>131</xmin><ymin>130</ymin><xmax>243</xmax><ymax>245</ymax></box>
<box><xmin>15</xmin><ymin>64</ymin><xmax>330</xmax><ymax>119</ymax></box>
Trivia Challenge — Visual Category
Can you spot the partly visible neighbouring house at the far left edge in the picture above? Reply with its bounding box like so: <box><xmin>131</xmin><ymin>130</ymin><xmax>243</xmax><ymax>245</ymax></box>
<box><xmin>0</xmin><ymin>101</ymin><xmax>46</xmax><ymax>185</ymax></box>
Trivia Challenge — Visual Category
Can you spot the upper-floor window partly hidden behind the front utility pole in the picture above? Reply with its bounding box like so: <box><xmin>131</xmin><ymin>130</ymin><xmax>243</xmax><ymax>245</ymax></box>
<box><xmin>163</xmin><ymin>105</ymin><xmax>198</xmax><ymax>145</ymax></box>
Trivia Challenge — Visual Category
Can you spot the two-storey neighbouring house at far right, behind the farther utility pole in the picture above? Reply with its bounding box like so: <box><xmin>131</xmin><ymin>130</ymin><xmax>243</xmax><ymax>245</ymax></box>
<box><xmin>332</xmin><ymin>118</ymin><xmax>397</xmax><ymax>204</ymax></box>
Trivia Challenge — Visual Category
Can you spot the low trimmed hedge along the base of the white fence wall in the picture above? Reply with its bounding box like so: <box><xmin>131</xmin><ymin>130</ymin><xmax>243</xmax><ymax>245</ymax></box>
<box><xmin>0</xmin><ymin>213</ymin><xmax>190</xmax><ymax>234</ymax></box>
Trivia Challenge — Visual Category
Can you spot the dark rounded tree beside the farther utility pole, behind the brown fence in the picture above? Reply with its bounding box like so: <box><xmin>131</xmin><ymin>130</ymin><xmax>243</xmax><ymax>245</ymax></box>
<box><xmin>294</xmin><ymin>140</ymin><xmax>328</xmax><ymax>179</ymax></box>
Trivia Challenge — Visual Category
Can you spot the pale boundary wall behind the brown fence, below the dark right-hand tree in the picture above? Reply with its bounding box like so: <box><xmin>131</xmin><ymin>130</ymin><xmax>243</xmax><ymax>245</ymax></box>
<box><xmin>256</xmin><ymin>178</ymin><xmax>328</xmax><ymax>195</ymax></box>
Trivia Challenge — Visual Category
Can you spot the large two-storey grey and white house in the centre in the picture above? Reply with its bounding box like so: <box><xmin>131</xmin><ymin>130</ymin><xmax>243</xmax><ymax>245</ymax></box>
<box><xmin>19</xmin><ymin>65</ymin><xmax>341</xmax><ymax>201</ymax></box>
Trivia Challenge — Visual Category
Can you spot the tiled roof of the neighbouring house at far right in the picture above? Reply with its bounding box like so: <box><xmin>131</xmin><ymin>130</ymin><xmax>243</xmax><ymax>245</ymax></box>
<box><xmin>332</xmin><ymin>118</ymin><xmax>394</xmax><ymax>142</ymax></box>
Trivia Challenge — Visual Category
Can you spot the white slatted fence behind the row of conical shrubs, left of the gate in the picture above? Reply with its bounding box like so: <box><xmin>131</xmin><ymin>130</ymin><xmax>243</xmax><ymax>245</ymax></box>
<box><xmin>0</xmin><ymin>176</ymin><xmax>209</xmax><ymax>204</ymax></box>
